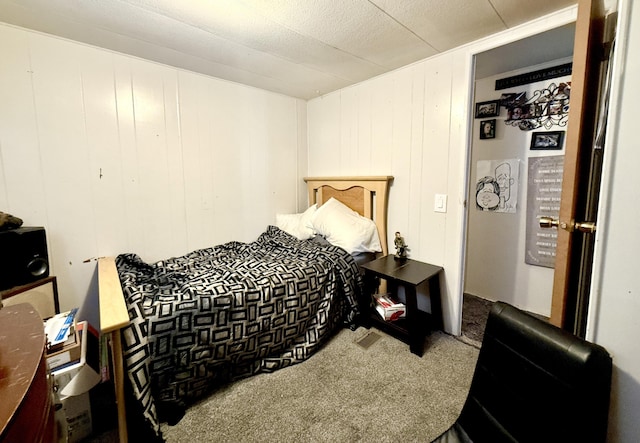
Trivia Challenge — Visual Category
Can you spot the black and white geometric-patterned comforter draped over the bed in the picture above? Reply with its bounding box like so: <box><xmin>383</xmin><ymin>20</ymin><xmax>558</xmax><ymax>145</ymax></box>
<box><xmin>116</xmin><ymin>226</ymin><xmax>362</xmax><ymax>435</ymax></box>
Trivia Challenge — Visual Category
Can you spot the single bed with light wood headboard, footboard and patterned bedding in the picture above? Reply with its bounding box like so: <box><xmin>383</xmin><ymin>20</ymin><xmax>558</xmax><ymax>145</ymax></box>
<box><xmin>98</xmin><ymin>176</ymin><xmax>393</xmax><ymax>441</ymax></box>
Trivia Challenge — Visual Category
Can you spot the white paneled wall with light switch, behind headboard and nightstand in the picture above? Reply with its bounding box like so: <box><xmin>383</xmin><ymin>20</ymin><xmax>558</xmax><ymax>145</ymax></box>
<box><xmin>307</xmin><ymin>53</ymin><xmax>462</xmax><ymax>331</ymax></box>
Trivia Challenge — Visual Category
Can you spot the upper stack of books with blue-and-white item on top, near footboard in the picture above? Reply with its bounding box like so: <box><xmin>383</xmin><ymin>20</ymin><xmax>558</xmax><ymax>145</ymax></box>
<box><xmin>44</xmin><ymin>308</ymin><xmax>81</xmax><ymax>371</ymax></box>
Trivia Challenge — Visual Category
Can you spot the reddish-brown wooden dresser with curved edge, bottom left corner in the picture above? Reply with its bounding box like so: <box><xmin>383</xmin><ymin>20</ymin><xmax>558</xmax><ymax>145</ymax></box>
<box><xmin>0</xmin><ymin>303</ymin><xmax>56</xmax><ymax>443</ymax></box>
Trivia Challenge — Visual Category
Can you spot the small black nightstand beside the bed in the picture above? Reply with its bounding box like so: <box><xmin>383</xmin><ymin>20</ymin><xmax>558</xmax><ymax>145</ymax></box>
<box><xmin>360</xmin><ymin>255</ymin><xmax>442</xmax><ymax>356</ymax></box>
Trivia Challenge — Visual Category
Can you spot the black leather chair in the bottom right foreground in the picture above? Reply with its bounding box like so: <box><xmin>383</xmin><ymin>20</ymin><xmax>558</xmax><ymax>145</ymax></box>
<box><xmin>433</xmin><ymin>302</ymin><xmax>611</xmax><ymax>443</ymax></box>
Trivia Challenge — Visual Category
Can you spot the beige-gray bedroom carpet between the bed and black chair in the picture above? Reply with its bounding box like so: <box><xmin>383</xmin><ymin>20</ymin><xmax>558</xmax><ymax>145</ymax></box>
<box><xmin>162</xmin><ymin>328</ymin><xmax>478</xmax><ymax>443</ymax></box>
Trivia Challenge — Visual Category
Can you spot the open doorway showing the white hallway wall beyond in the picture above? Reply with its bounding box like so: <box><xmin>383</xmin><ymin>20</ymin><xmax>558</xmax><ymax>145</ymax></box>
<box><xmin>462</xmin><ymin>23</ymin><xmax>575</xmax><ymax>342</ymax></box>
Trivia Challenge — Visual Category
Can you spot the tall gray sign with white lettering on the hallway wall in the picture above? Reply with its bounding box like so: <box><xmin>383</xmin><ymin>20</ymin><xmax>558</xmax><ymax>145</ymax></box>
<box><xmin>524</xmin><ymin>155</ymin><xmax>564</xmax><ymax>268</ymax></box>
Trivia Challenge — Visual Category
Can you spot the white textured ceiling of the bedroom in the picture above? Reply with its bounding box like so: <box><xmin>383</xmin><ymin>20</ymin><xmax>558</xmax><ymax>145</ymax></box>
<box><xmin>0</xmin><ymin>0</ymin><xmax>576</xmax><ymax>99</ymax></box>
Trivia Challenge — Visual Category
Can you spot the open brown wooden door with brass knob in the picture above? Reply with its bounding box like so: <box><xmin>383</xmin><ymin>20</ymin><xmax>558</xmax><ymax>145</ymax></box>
<box><xmin>550</xmin><ymin>0</ymin><xmax>604</xmax><ymax>335</ymax></box>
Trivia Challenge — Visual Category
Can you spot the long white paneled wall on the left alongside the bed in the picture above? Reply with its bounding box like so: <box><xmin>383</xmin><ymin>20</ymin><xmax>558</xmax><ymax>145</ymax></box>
<box><xmin>0</xmin><ymin>24</ymin><xmax>307</xmax><ymax>309</ymax></box>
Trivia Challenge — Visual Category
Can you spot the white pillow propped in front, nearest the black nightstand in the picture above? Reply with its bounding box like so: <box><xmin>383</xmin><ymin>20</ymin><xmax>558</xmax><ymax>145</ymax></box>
<box><xmin>311</xmin><ymin>197</ymin><xmax>382</xmax><ymax>254</ymax></box>
